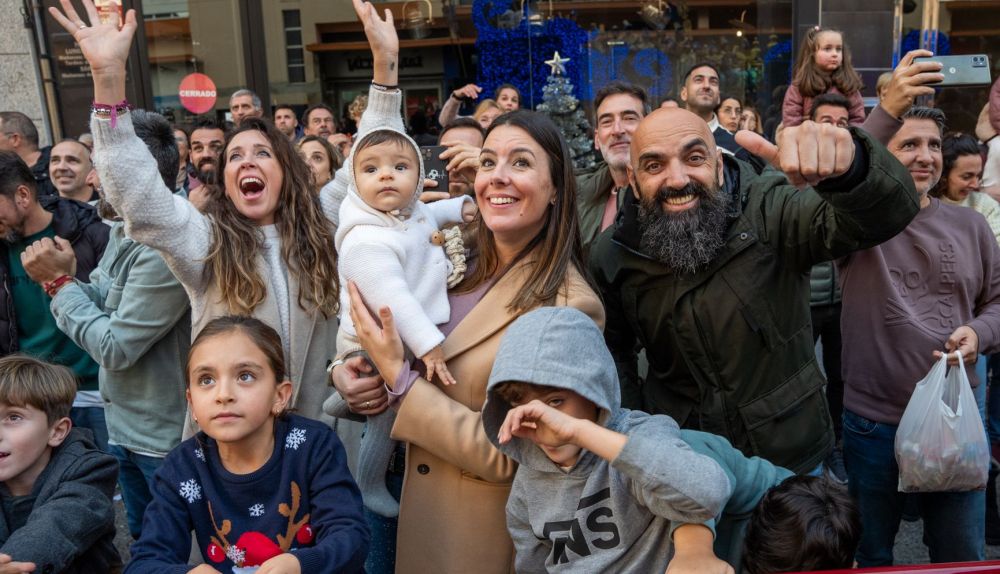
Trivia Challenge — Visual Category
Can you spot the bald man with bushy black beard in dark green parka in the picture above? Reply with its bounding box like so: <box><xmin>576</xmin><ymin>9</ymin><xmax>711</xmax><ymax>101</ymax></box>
<box><xmin>590</xmin><ymin>109</ymin><xmax>919</xmax><ymax>473</ymax></box>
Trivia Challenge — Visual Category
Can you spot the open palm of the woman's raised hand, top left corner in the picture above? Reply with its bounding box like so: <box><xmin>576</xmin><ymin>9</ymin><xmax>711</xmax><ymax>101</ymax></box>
<box><xmin>49</xmin><ymin>0</ymin><xmax>136</xmax><ymax>73</ymax></box>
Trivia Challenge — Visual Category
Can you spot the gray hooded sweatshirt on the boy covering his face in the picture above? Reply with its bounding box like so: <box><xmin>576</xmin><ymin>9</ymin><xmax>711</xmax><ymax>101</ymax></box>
<box><xmin>483</xmin><ymin>307</ymin><xmax>730</xmax><ymax>572</ymax></box>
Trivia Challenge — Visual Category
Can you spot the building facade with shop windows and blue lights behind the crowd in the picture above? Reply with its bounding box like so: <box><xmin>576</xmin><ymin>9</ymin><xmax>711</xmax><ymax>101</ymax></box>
<box><xmin>7</xmin><ymin>0</ymin><xmax>1000</xmax><ymax>139</ymax></box>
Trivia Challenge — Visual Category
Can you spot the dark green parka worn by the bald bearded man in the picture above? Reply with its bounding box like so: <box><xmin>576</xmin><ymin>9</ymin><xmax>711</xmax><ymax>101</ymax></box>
<box><xmin>590</xmin><ymin>129</ymin><xmax>919</xmax><ymax>473</ymax></box>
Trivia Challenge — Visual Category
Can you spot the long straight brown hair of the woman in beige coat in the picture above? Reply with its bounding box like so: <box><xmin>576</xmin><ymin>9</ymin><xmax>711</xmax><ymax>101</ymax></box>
<box><xmin>456</xmin><ymin>110</ymin><xmax>587</xmax><ymax>313</ymax></box>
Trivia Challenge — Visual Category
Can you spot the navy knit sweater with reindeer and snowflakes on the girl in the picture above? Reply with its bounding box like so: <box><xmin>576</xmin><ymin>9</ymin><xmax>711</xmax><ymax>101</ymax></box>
<box><xmin>126</xmin><ymin>415</ymin><xmax>368</xmax><ymax>574</ymax></box>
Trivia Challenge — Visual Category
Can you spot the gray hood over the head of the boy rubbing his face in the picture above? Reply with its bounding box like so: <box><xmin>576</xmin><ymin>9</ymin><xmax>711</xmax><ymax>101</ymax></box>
<box><xmin>483</xmin><ymin>307</ymin><xmax>628</xmax><ymax>474</ymax></box>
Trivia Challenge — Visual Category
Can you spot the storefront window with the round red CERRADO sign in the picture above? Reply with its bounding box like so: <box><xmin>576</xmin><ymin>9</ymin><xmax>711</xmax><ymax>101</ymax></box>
<box><xmin>142</xmin><ymin>0</ymin><xmax>247</xmax><ymax>124</ymax></box>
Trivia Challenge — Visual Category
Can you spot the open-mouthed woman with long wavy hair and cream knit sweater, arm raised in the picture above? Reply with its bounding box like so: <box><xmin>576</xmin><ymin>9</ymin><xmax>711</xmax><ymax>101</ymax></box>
<box><xmin>50</xmin><ymin>0</ymin><xmax>351</xmax><ymax>432</ymax></box>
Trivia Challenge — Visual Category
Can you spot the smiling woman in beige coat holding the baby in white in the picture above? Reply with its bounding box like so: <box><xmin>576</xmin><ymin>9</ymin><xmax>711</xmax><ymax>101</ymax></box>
<box><xmin>333</xmin><ymin>6</ymin><xmax>604</xmax><ymax>573</ymax></box>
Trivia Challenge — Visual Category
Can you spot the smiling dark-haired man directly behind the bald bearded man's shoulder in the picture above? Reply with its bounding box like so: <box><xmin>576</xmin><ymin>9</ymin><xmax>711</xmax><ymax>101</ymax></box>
<box><xmin>576</xmin><ymin>82</ymin><xmax>649</xmax><ymax>246</ymax></box>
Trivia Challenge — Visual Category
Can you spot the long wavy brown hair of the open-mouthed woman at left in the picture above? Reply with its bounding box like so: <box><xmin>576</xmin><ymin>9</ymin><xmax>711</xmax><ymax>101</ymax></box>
<box><xmin>205</xmin><ymin>118</ymin><xmax>340</xmax><ymax>318</ymax></box>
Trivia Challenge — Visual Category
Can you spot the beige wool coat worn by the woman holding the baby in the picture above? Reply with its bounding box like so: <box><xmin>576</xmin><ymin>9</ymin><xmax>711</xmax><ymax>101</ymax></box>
<box><xmin>392</xmin><ymin>263</ymin><xmax>604</xmax><ymax>574</ymax></box>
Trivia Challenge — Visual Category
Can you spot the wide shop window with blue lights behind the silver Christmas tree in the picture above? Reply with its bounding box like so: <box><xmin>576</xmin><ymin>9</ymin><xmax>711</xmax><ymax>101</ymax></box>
<box><xmin>292</xmin><ymin>0</ymin><xmax>793</xmax><ymax>145</ymax></box>
